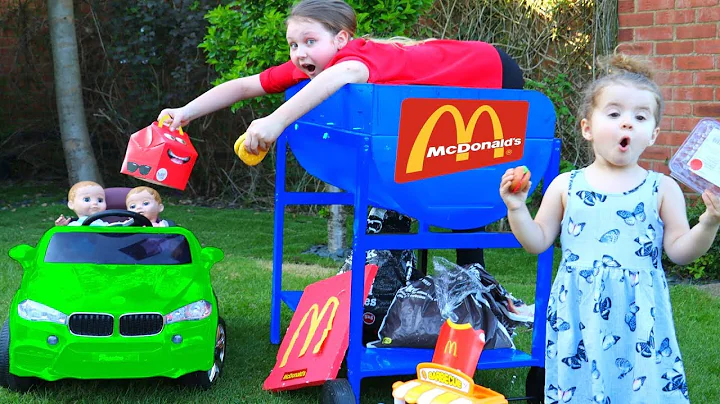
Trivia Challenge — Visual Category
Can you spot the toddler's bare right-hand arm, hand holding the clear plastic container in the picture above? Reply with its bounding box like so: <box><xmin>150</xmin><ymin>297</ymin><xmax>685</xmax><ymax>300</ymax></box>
<box><xmin>660</xmin><ymin>177</ymin><xmax>720</xmax><ymax>265</ymax></box>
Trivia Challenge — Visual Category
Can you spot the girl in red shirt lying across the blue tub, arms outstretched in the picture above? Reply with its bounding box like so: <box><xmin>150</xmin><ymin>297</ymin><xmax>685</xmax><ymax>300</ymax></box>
<box><xmin>158</xmin><ymin>0</ymin><xmax>524</xmax><ymax>154</ymax></box>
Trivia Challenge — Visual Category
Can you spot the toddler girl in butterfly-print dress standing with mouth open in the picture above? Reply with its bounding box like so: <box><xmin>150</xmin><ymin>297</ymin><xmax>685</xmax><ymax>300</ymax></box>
<box><xmin>500</xmin><ymin>55</ymin><xmax>720</xmax><ymax>404</ymax></box>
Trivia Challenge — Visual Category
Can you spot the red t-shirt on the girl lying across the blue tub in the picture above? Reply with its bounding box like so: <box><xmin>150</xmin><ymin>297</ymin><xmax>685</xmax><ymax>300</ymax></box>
<box><xmin>260</xmin><ymin>38</ymin><xmax>502</xmax><ymax>93</ymax></box>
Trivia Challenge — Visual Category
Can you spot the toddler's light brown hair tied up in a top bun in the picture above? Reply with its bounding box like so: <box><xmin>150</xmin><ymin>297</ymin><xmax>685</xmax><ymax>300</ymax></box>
<box><xmin>579</xmin><ymin>53</ymin><xmax>665</xmax><ymax>127</ymax></box>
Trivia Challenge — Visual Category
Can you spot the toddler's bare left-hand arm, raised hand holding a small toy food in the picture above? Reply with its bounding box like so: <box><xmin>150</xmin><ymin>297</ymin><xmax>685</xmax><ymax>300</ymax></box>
<box><xmin>500</xmin><ymin>170</ymin><xmax>570</xmax><ymax>254</ymax></box>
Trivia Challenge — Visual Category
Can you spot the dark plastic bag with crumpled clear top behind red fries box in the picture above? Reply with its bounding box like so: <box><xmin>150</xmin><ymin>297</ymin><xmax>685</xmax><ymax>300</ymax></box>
<box><xmin>371</xmin><ymin>257</ymin><xmax>515</xmax><ymax>349</ymax></box>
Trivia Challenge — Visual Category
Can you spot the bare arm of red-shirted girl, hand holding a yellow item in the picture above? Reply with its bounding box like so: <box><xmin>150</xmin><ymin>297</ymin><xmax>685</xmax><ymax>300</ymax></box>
<box><xmin>245</xmin><ymin>60</ymin><xmax>370</xmax><ymax>154</ymax></box>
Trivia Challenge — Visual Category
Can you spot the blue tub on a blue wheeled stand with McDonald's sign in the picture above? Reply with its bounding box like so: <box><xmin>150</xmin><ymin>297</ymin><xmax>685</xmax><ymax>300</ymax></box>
<box><xmin>265</xmin><ymin>84</ymin><xmax>560</xmax><ymax>403</ymax></box>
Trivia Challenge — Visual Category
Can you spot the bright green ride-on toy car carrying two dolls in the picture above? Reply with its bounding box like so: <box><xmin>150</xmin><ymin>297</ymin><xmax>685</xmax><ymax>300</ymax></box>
<box><xmin>0</xmin><ymin>210</ymin><xmax>226</xmax><ymax>391</ymax></box>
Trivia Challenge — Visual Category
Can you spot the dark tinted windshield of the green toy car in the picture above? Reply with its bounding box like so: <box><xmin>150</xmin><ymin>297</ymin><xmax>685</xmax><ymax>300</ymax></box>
<box><xmin>45</xmin><ymin>232</ymin><xmax>192</xmax><ymax>265</ymax></box>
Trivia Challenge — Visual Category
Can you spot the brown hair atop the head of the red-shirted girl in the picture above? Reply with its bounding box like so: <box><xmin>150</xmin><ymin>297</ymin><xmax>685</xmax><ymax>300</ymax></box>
<box><xmin>285</xmin><ymin>0</ymin><xmax>357</xmax><ymax>37</ymax></box>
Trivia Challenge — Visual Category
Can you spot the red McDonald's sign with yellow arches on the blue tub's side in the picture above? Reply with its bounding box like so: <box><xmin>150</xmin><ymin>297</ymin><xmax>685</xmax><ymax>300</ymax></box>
<box><xmin>395</xmin><ymin>98</ymin><xmax>528</xmax><ymax>183</ymax></box>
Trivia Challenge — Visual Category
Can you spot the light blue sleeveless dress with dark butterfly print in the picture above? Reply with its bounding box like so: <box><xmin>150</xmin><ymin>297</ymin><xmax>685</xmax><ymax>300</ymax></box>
<box><xmin>545</xmin><ymin>170</ymin><xmax>688</xmax><ymax>404</ymax></box>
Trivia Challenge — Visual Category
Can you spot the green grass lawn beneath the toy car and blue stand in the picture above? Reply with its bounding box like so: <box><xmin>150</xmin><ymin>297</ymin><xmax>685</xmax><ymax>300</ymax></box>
<box><xmin>0</xmin><ymin>184</ymin><xmax>720</xmax><ymax>403</ymax></box>
